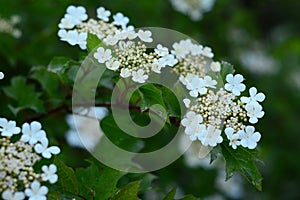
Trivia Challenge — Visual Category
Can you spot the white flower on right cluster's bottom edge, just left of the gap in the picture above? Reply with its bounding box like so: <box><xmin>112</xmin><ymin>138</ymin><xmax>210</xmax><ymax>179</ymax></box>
<box><xmin>201</xmin><ymin>125</ymin><xmax>223</xmax><ymax>147</ymax></box>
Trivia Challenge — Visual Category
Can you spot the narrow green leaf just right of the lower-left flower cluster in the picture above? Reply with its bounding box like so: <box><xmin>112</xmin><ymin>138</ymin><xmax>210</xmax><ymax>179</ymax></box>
<box><xmin>54</xmin><ymin>157</ymin><xmax>79</xmax><ymax>196</ymax></box>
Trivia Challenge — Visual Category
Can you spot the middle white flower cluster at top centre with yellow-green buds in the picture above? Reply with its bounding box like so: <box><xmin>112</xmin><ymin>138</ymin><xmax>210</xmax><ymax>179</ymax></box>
<box><xmin>94</xmin><ymin>37</ymin><xmax>178</xmax><ymax>83</ymax></box>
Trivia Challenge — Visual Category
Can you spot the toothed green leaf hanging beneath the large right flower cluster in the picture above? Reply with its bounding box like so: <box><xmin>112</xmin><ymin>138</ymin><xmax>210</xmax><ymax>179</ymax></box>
<box><xmin>221</xmin><ymin>143</ymin><xmax>262</xmax><ymax>191</ymax></box>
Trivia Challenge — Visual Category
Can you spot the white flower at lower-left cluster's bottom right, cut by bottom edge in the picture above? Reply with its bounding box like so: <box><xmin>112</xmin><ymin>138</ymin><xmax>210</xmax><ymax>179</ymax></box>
<box><xmin>25</xmin><ymin>181</ymin><xmax>48</xmax><ymax>200</ymax></box>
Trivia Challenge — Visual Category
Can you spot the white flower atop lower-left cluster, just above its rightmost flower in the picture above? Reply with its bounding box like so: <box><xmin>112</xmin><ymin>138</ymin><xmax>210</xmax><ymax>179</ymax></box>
<box><xmin>20</xmin><ymin>121</ymin><xmax>46</xmax><ymax>144</ymax></box>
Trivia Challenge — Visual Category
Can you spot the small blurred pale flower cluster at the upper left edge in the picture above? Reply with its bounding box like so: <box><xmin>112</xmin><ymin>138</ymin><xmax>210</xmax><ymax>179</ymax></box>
<box><xmin>0</xmin><ymin>15</ymin><xmax>22</xmax><ymax>38</ymax></box>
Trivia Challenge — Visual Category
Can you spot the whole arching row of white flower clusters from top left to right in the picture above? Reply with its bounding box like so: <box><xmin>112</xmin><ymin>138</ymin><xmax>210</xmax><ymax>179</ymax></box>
<box><xmin>59</xmin><ymin>6</ymin><xmax>265</xmax><ymax>152</ymax></box>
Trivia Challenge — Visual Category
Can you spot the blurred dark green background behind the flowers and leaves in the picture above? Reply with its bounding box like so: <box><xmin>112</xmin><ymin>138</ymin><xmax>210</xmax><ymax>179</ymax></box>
<box><xmin>0</xmin><ymin>0</ymin><xmax>300</xmax><ymax>199</ymax></box>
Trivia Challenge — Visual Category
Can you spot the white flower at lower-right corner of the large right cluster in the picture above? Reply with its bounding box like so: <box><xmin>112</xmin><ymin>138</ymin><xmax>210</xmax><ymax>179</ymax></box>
<box><xmin>238</xmin><ymin>126</ymin><xmax>261</xmax><ymax>149</ymax></box>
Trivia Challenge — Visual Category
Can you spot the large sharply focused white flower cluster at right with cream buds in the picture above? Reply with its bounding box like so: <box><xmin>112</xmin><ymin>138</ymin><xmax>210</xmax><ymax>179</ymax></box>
<box><xmin>181</xmin><ymin>69</ymin><xmax>265</xmax><ymax>149</ymax></box>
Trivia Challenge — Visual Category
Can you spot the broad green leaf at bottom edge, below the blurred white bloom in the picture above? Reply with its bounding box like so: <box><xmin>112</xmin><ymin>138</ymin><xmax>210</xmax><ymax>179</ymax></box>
<box><xmin>76</xmin><ymin>161</ymin><xmax>124</xmax><ymax>200</ymax></box>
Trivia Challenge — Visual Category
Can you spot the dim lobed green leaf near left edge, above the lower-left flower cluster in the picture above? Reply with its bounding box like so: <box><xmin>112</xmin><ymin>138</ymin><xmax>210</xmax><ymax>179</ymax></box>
<box><xmin>4</xmin><ymin>76</ymin><xmax>45</xmax><ymax>115</ymax></box>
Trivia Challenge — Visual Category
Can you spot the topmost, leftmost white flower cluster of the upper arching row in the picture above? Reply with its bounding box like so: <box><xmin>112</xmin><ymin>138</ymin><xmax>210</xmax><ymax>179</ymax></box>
<box><xmin>58</xmin><ymin>5</ymin><xmax>134</xmax><ymax>50</ymax></box>
